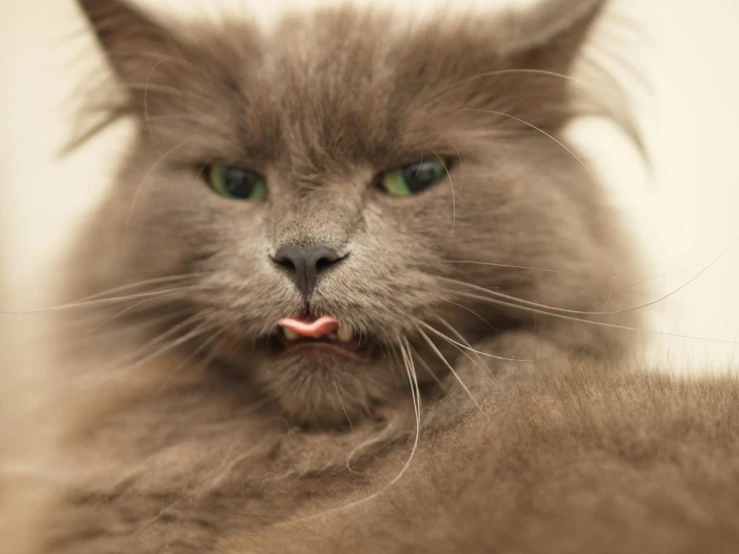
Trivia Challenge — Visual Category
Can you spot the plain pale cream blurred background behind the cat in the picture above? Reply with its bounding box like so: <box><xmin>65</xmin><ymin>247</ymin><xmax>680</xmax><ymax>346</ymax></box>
<box><xmin>0</xmin><ymin>0</ymin><xmax>739</xmax><ymax>371</ymax></box>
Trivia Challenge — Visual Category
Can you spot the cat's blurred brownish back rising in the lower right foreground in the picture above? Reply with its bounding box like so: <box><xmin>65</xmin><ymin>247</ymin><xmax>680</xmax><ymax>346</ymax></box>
<box><xmin>244</xmin><ymin>368</ymin><xmax>739</xmax><ymax>554</ymax></box>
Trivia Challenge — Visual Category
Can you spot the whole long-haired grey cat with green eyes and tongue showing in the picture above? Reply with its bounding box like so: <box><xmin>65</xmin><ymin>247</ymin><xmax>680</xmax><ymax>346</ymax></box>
<box><xmin>6</xmin><ymin>0</ymin><xmax>739</xmax><ymax>554</ymax></box>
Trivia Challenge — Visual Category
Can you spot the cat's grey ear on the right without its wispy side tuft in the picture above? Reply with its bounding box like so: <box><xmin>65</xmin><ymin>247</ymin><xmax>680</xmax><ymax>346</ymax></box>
<box><xmin>498</xmin><ymin>0</ymin><xmax>608</xmax><ymax>73</ymax></box>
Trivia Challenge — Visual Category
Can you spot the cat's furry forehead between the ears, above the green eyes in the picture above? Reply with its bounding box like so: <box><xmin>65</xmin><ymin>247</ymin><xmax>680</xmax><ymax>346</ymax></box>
<box><xmin>202</xmin><ymin>8</ymin><xmax>490</xmax><ymax>171</ymax></box>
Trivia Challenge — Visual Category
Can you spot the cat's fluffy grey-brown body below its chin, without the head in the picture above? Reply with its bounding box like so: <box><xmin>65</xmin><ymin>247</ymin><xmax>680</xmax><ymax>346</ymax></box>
<box><xmin>10</xmin><ymin>352</ymin><xmax>739</xmax><ymax>554</ymax></box>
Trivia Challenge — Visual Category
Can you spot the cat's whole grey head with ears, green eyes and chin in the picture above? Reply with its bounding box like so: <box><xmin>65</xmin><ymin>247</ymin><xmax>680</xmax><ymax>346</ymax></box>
<box><xmin>79</xmin><ymin>0</ymin><xmax>640</xmax><ymax>424</ymax></box>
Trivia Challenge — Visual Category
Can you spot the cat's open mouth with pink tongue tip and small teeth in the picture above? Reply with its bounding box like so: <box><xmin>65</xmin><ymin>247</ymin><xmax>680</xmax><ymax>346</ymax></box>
<box><xmin>273</xmin><ymin>316</ymin><xmax>370</xmax><ymax>362</ymax></box>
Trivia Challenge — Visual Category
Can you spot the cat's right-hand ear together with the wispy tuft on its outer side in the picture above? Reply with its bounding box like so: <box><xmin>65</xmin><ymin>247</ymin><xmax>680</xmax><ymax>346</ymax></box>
<box><xmin>486</xmin><ymin>0</ymin><xmax>646</xmax><ymax>151</ymax></box>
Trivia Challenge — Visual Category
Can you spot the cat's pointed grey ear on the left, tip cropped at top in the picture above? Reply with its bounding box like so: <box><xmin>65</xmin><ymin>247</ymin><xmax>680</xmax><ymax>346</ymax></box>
<box><xmin>77</xmin><ymin>0</ymin><xmax>179</xmax><ymax>83</ymax></box>
